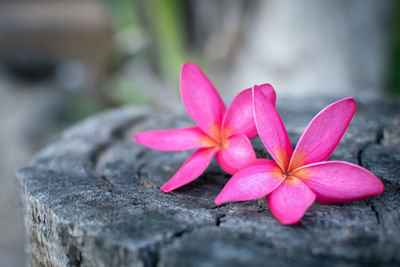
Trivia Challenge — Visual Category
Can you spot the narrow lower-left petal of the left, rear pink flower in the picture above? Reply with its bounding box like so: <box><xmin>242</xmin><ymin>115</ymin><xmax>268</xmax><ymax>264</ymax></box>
<box><xmin>161</xmin><ymin>148</ymin><xmax>216</xmax><ymax>193</ymax></box>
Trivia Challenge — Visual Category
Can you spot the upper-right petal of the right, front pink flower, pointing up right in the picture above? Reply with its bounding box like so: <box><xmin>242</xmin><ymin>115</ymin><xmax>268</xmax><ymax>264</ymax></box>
<box><xmin>289</xmin><ymin>97</ymin><xmax>356</xmax><ymax>170</ymax></box>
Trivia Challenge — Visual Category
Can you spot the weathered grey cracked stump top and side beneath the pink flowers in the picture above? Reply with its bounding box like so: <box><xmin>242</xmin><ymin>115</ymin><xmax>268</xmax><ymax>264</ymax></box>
<box><xmin>17</xmin><ymin>99</ymin><xmax>400</xmax><ymax>266</ymax></box>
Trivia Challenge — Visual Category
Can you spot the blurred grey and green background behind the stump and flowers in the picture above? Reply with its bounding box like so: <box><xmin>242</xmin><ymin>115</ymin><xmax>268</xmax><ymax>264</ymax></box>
<box><xmin>0</xmin><ymin>0</ymin><xmax>400</xmax><ymax>266</ymax></box>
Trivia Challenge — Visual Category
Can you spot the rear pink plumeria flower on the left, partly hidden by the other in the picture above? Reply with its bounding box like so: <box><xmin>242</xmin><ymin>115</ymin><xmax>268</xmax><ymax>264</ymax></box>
<box><xmin>134</xmin><ymin>63</ymin><xmax>276</xmax><ymax>193</ymax></box>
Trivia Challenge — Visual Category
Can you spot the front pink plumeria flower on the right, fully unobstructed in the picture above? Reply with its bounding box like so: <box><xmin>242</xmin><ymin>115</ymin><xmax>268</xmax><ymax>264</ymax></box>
<box><xmin>215</xmin><ymin>86</ymin><xmax>383</xmax><ymax>224</ymax></box>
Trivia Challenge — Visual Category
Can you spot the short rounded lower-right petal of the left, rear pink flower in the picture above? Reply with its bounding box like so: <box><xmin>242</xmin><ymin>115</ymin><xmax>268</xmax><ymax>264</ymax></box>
<box><xmin>215</xmin><ymin>134</ymin><xmax>256</xmax><ymax>174</ymax></box>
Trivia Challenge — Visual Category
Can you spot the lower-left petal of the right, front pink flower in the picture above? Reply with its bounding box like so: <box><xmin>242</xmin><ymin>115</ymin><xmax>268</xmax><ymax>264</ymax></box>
<box><xmin>215</xmin><ymin>159</ymin><xmax>284</xmax><ymax>205</ymax></box>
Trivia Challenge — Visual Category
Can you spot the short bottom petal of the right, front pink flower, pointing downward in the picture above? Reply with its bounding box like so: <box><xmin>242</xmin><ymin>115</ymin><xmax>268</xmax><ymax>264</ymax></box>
<box><xmin>267</xmin><ymin>176</ymin><xmax>315</xmax><ymax>224</ymax></box>
